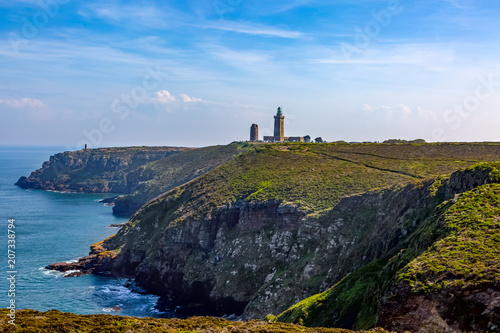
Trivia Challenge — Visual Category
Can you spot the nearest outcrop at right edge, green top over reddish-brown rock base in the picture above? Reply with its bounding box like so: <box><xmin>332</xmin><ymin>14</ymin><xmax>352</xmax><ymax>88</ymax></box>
<box><xmin>377</xmin><ymin>165</ymin><xmax>500</xmax><ymax>333</ymax></box>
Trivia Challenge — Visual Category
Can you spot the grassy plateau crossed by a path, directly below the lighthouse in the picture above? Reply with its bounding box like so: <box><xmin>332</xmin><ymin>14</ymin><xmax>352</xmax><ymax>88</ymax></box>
<box><xmin>134</xmin><ymin>143</ymin><xmax>500</xmax><ymax>222</ymax></box>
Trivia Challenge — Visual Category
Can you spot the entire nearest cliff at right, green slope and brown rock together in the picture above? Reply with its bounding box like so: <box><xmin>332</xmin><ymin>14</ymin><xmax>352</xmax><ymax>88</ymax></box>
<box><xmin>278</xmin><ymin>163</ymin><xmax>500</xmax><ymax>333</ymax></box>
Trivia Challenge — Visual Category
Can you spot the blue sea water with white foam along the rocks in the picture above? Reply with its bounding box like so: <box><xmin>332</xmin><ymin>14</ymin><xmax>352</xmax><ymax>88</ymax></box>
<box><xmin>0</xmin><ymin>147</ymin><xmax>160</xmax><ymax>317</ymax></box>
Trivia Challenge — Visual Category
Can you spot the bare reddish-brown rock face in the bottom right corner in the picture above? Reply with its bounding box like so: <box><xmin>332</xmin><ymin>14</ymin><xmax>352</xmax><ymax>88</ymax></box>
<box><xmin>377</xmin><ymin>283</ymin><xmax>500</xmax><ymax>333</ymax></box>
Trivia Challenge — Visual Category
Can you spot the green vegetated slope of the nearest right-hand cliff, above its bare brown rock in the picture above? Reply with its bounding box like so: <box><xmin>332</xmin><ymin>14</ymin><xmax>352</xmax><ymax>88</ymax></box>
<box><xmin>277</xmin><ymin>163</ymin><xmax>500</xmax><ymax>329</ymax></box>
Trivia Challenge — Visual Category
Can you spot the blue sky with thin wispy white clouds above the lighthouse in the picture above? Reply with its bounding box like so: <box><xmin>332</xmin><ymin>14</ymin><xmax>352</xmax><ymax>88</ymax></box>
<box><xmin>0</xmin><ymin>0</ymin><xmax>500</xmax><ymax>150</ymax></box>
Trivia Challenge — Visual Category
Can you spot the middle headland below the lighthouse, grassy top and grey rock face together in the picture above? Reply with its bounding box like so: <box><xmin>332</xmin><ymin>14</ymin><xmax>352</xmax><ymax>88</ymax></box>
<box><xmin>46</xmin><ymin>144</ymin><xmax>500</xmax><ymax>327</ymax></box>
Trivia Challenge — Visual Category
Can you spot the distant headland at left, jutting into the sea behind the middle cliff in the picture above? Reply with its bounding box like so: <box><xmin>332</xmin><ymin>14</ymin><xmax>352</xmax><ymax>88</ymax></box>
<box><xmin>15</xmin><ymin>143</ymin><xmax>253</xmax><ymax>217</ymax></box>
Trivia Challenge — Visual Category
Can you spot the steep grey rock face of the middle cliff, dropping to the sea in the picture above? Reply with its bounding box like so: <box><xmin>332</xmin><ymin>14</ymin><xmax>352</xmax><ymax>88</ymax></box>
<box><xmin>57</xmin><ymin>175</ymin><xmax>442</xmax><ymax>318</ymax></box>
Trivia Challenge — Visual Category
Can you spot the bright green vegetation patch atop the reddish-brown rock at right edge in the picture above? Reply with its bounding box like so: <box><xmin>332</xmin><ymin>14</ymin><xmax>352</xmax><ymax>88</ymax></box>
<box><xmin>397</xmin><ymin>184</ymin><xmax>500</xmax><ymax>293</ymax></box>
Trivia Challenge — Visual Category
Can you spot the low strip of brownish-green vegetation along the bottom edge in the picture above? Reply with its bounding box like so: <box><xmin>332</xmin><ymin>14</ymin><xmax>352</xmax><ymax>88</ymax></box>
<box><xmin>0</xmin><ymin>310</ymin><xmax>386</xmax><ymax>333</ymax></box>
